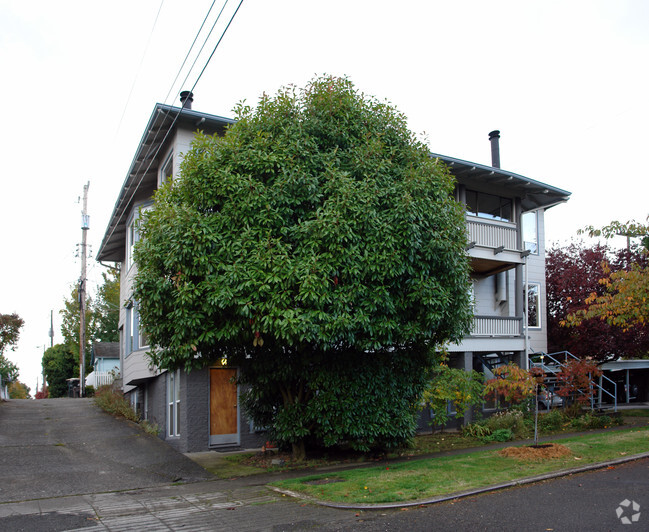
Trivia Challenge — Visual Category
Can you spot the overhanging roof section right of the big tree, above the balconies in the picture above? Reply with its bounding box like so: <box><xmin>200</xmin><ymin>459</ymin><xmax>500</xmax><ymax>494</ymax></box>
<box><xmin>431</xmin><ymin>153</ymin><xmax>571</xmax><ymax>212</ymax></box>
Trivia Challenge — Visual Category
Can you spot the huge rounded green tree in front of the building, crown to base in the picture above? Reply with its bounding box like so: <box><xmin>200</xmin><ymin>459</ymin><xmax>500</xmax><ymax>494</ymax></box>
<box><xmin>135</xmin><ymin>77</ymin><xmax>471</xmax><ymax>458</ymax></box>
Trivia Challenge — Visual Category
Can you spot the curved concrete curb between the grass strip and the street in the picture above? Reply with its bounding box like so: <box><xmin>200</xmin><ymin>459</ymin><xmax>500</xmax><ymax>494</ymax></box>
<box><xmin>268</xmin><ymin>452</ymin><xmax>649</xmax><ymax>510</ymax></box>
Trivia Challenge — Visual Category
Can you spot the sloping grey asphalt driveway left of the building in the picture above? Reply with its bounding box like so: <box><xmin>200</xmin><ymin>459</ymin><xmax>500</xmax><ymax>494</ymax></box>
<box><xmin>0</xmin><ymin>399</ymin><xmax>213</xmax><ymax>503</ymax></box>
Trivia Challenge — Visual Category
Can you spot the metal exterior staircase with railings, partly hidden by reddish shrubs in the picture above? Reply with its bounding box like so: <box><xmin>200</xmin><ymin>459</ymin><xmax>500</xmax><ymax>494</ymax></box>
<box><xmin>529</xmin><ymin>351</ymin><xmax>617</xmax><ymax>412</ymax></box>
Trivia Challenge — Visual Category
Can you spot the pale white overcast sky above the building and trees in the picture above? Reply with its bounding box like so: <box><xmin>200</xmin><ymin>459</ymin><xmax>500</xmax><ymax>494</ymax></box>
<box><xmin>0</xmin><ymin>0</ymin><xmax>649</xmax><ymax>393</ymax></box>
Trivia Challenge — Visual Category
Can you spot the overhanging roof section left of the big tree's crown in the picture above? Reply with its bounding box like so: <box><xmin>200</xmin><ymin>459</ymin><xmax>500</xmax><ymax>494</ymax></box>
<box><xmin>97</xmin><ymin>103</ymin><xmax>234</xmax><ymax>262</ymax></box>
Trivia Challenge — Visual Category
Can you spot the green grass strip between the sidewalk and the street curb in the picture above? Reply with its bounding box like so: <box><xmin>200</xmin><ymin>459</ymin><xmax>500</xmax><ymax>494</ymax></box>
<box><xmin>272</xmin><ymin>428</ymin><xmax>649</xmax><ymax>504</ymax></box>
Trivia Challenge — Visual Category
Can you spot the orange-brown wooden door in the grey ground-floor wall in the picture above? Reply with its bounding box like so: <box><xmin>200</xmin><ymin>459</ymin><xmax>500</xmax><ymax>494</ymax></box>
<box><xmin>210</xmin><ymin>368</ymin><xmax>239</xmax><ymax>445</ymax></box>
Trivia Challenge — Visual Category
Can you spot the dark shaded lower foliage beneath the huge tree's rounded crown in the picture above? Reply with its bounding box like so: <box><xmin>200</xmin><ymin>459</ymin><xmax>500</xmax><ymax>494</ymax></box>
<box><xmin>242</xmin><ymin>350</ymin><xmax>430</xmax><ymax>451</ymax></box>
